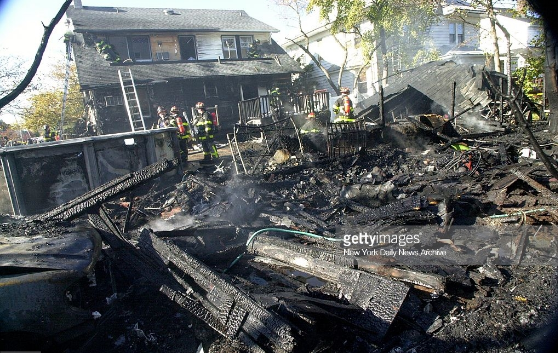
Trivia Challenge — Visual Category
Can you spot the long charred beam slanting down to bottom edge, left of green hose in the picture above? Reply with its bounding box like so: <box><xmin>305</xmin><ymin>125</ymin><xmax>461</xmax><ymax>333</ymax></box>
<box><xmin>147</xmin><ymin>233</ymin><xmax>295</xmax><ymax>352</ymax></box>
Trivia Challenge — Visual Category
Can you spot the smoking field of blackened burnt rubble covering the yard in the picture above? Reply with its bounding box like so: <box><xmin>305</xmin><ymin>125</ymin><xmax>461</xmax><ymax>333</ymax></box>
<box><xmin>2</xmin><ymin>114</ymin><xmax>558</xmax><ymax>352</ymax></box>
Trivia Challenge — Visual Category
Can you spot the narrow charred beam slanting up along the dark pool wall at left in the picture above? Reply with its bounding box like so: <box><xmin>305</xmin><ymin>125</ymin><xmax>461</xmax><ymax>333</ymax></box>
<box><xmin>34</xmin><ymin>159</ymin><xmax>179</xmax><ymax>221</ymax></box>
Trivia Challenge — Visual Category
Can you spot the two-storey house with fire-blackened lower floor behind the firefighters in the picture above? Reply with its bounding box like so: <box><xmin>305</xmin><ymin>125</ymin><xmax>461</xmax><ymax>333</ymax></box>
<box><xmin>66</xmin><ymin>1</ymin><xmax>300</xmax><ymax>134</ymax></box>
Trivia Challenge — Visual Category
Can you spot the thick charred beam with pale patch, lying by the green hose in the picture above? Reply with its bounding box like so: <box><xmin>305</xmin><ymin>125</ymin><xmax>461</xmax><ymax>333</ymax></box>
<box><xmin>248</xmin><ymin>236</ymin><xmax>409</xmax><ymax>339</ymax></box>
